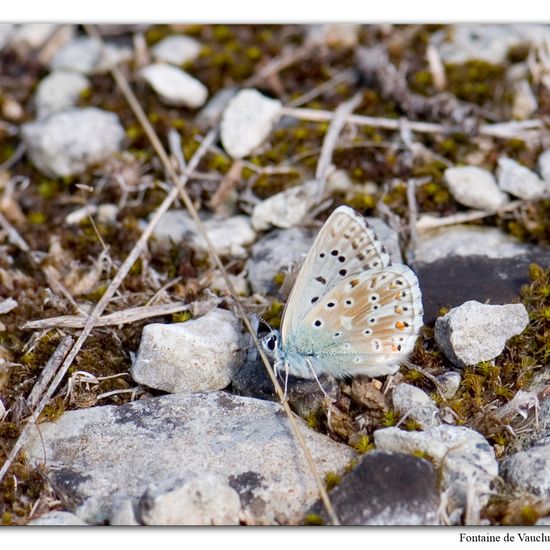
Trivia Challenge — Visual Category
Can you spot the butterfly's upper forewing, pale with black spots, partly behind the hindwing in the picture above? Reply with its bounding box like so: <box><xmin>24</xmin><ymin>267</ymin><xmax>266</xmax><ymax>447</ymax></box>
<box><xmin>281</xmin><ymin>206</ymin><xmax>391</xmax><ymax>346</ymax></box>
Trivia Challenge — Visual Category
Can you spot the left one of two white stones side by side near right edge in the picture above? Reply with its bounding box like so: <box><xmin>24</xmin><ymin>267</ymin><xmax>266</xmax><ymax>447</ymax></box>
<box><xmin>445</xmin><ymin>166</ymin><xmax>508</xmax><ymax>212</ymax></box>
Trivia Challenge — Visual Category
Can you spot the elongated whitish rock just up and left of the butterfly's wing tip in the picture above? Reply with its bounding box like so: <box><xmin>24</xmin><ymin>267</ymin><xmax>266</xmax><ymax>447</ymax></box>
<box><xmin>252</xmin><ymin>180</ymin><xmax>321</xmax><ymax>231</ymax></box>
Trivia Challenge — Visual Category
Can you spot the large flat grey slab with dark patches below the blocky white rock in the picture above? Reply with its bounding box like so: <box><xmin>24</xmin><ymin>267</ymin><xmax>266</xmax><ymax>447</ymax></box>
<box><xmin>25</xmin><ymin>392</ymin><xmax>355</xmax><ymax>524</ymax></box>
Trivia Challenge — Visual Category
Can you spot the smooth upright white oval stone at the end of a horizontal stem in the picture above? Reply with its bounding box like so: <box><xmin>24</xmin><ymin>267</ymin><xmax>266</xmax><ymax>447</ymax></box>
<box><xmin>221</xmin><ymin>89</ymin><xmax>282</xmax><ymax>159</ymax></box>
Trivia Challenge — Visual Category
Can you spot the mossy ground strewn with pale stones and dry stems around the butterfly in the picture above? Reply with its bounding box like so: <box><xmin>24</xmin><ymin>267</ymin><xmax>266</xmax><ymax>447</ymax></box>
<box><xmin>0</xmin><ymin>24</ymin><xmax>550</xmax><ymax>525</ymax></box>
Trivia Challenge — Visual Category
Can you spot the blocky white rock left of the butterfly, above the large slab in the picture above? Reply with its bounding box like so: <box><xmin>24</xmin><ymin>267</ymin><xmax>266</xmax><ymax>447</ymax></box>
<box><xmin>131</xmin><ymin>309</ymin><xmax>243</xmax><ymax>393</ymax></box>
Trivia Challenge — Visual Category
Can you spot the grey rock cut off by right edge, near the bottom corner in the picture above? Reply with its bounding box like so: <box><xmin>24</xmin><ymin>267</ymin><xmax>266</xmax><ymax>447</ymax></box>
<box><xmin>500</xmin><ymin>445</ymin><xmax>550</xmax><ymax>496</ymax></box>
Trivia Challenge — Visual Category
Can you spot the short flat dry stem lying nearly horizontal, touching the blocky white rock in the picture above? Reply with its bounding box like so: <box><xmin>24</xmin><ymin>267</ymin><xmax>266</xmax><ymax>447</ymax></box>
<box><xmin>23</xmin><ymin>302</ymin><xmax>191</xmax><ymax>330</ymax></box>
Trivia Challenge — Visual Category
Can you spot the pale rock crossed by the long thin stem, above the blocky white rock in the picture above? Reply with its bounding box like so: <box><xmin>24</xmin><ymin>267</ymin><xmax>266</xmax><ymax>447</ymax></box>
<box><xmin>153</xmin><ymin>210</ymin><xmax>256</xmax><ymax>258</ymax></box>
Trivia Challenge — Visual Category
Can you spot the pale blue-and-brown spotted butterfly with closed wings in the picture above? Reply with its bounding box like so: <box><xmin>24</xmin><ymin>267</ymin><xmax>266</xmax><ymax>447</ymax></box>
<box><xmin>261</xmin><ymin>206</ymin><xmax>423</xmax><ymax>379</ymax></box>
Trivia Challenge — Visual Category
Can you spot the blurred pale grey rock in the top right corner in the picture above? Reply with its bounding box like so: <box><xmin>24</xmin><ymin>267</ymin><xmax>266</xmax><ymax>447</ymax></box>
<box><xmin>431</xmin><ymin>24</ymin><xmax>550</xmax><ymax>64</ymax></box>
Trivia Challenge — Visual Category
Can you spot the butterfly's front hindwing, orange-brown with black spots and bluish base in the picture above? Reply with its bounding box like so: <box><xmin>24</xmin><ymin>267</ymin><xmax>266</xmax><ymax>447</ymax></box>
<box><xmin>286</xmin><ymin>265</ymin><xmax>423</xmax><ymax>378</ymax></box>
